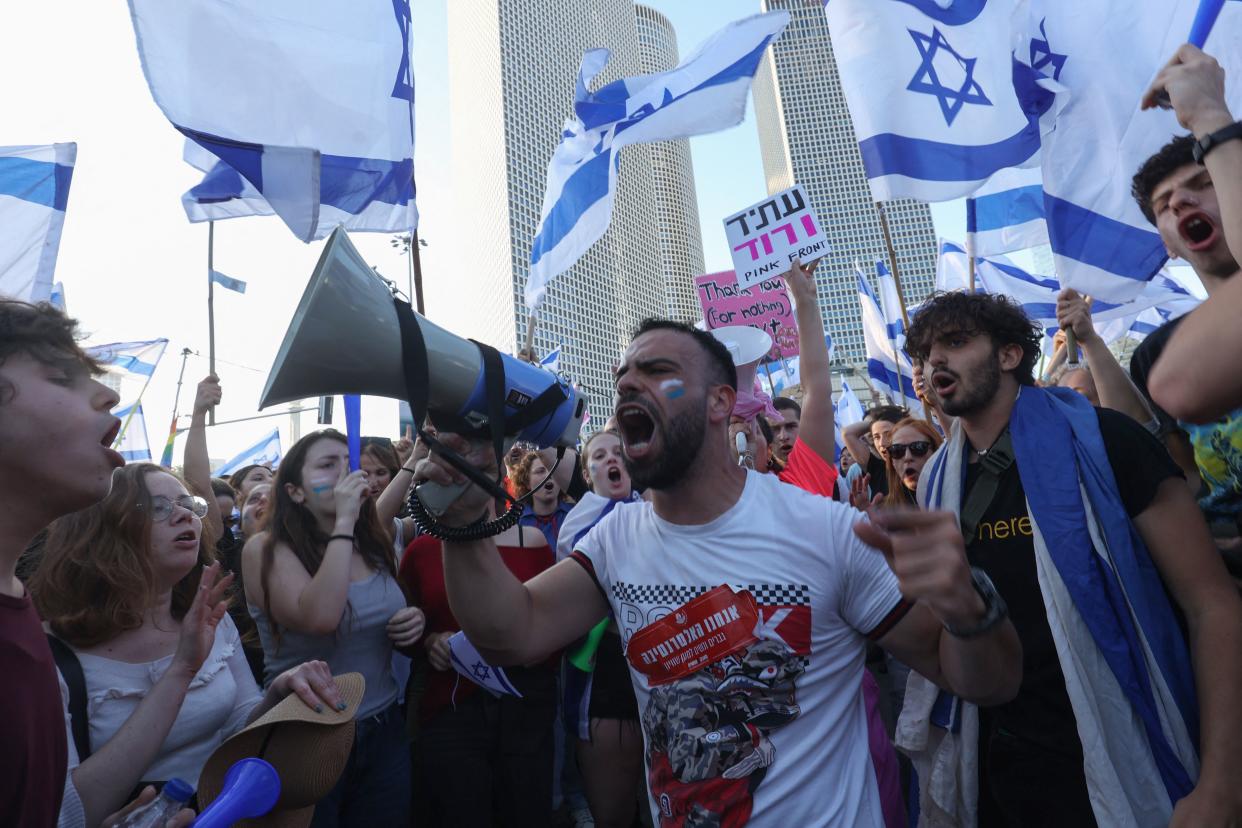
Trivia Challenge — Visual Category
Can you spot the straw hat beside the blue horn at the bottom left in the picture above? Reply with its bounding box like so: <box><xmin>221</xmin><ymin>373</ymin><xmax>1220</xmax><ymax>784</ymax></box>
<box><xmin>199</xmin><ymin>673</ymin><xmax>366</xmax><ymax>828</ymax></box>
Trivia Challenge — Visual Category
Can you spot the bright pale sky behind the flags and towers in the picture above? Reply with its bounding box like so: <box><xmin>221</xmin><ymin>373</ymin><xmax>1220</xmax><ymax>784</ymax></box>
<box><xmin>0</xmin><ymin>0</ymin><xmax>965</xmax><ymax>463</ymax></box>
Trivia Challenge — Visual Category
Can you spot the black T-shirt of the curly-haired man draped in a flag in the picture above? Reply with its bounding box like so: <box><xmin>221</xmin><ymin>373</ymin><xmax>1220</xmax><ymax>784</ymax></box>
<box><xmin>966</xmin><ymin>408</ymin><xmax>1181</xmax><ymax>762</ymax></box>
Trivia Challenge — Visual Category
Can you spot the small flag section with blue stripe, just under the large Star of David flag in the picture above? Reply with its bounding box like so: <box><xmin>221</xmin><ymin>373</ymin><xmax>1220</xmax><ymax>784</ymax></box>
<box><xmin>966</xmin><ymin>168</ymin><xmax>1048</xmax><ymax>256</ymax></box>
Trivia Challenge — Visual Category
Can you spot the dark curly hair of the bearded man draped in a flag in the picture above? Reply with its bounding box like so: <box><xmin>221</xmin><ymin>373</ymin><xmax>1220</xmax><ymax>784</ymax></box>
<box><xmin>905</xmin><ymin>290</ymin><xmax>1043</xmax><ymax>385</ymax></box>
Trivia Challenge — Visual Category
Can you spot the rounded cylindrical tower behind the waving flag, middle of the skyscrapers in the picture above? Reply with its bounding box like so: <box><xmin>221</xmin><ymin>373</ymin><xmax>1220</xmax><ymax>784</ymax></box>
<box><xmin>633</xmin><ymin>5</ymin><xmax>703</xmax><ymax>323</ymax></box>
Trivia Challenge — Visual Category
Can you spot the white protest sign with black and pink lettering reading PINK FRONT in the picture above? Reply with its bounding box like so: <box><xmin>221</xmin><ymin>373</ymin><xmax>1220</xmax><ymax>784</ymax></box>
<box><xmin>724</xmin><ymin>185</ymin><xmax>831</xmax><ymax>288</ymax></box>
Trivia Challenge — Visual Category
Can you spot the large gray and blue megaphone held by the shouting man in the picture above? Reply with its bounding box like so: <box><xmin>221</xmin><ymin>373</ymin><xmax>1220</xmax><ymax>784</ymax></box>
<box><xmin>260</xmin><ymin>227</ymin><xmax>585</xmax><ymax>513</ymax></box>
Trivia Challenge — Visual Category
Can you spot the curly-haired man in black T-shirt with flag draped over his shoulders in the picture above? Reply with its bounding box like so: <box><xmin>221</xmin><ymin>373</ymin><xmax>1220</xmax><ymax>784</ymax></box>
<box><xmin>903</xmin><ymin>293</ymin><xmax>1242</xmax><ymax>826</ymax></box>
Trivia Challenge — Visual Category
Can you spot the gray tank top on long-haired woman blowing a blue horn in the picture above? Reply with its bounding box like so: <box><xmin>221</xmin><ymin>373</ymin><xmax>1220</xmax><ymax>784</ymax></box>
<box><xmin>248</xmin><ymin>572</ymin><xmax>405</xmax><ymax>719</ymax></box>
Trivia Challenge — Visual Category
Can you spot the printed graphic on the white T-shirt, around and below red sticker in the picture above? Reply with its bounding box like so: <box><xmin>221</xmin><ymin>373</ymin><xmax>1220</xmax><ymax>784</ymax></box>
<box><xmin>627</xmin><ymin>592</ymin><xmax>811</xmax><ymax>828</ymax></box>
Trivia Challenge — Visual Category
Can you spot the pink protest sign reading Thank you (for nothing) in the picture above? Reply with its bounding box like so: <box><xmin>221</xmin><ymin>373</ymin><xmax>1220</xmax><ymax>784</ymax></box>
<box><xmin>694</xmin><ymin>271</ymin><xmax>797</xmax><ymax>359</ymax></box>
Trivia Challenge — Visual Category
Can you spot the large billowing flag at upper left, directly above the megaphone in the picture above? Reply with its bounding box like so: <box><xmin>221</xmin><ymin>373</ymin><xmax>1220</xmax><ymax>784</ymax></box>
<box><xmin>129</xmin><ymin>0</ymin><xmax>417</xmax><ymax>241</ymax></box>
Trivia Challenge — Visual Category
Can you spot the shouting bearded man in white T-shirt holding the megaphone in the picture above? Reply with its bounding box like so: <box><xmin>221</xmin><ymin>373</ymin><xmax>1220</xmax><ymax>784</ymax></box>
<box><xmin>415</xmin><ymin>320</ymin><xmax>1022</xmax><ymax>828</ymax></box>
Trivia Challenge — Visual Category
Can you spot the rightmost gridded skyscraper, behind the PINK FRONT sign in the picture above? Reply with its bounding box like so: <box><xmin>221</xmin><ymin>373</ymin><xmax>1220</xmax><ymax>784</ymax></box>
<box><xmin>753</xmin><ymin>0</ymin><xmax>936</xmax><ymax>364</ymax></box>
